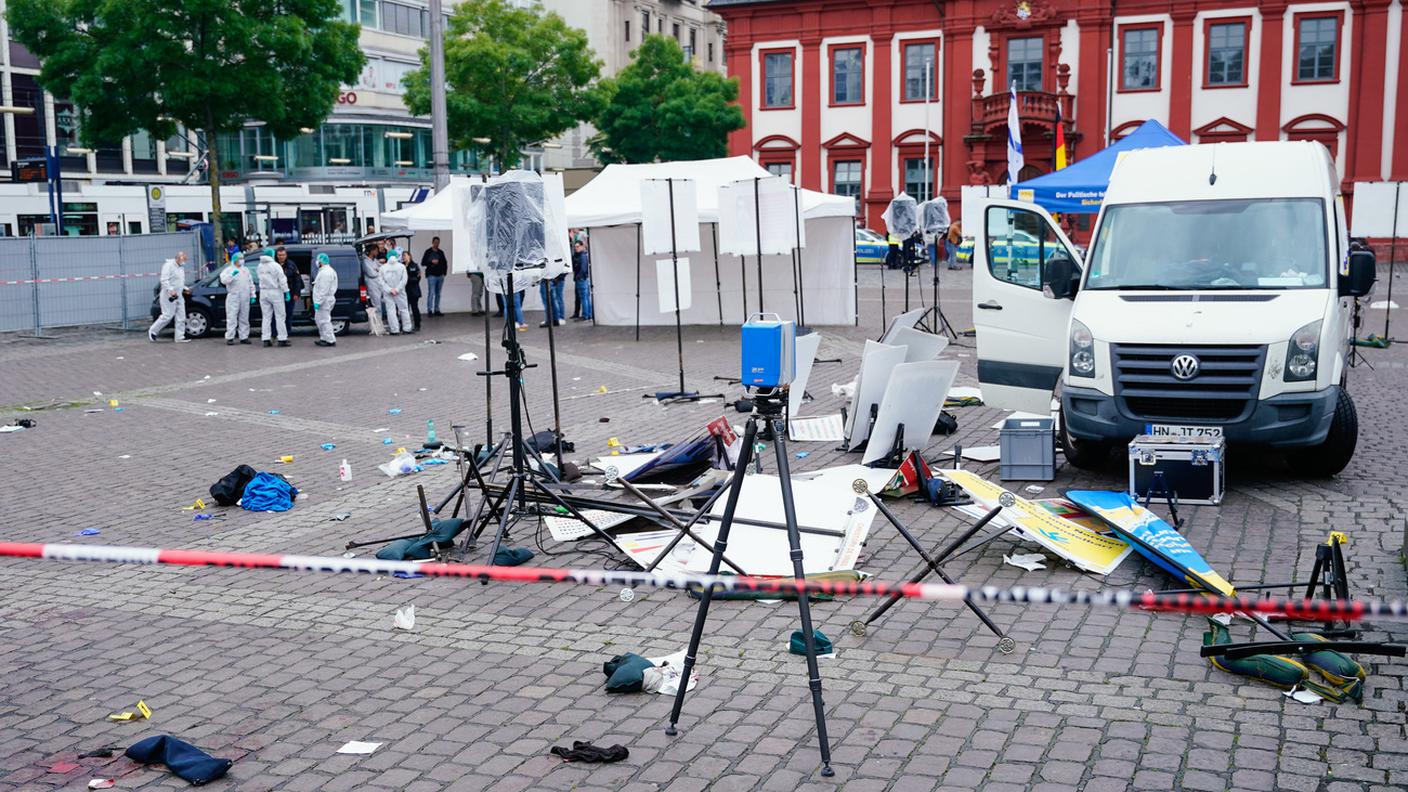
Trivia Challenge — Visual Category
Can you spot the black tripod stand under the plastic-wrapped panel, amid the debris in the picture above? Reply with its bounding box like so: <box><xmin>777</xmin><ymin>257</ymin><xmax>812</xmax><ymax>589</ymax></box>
<box><xmin>461</xmin><ymin>271</ymin><xmax>622</xmax><ymax>564</ymax></box>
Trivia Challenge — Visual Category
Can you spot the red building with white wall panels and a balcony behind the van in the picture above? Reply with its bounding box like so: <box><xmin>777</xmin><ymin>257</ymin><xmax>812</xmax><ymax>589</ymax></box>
<box><xmin>708</xmin><ymin>0</ymin><xmax>1408</xmax><ymax>227</ymax></box>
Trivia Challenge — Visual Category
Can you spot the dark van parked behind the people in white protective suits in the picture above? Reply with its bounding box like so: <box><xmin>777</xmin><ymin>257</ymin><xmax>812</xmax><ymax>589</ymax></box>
<box><xmin>152</xmin><ymin>245</ymin><xmax>366</xmax><ymax>338</ymax></box>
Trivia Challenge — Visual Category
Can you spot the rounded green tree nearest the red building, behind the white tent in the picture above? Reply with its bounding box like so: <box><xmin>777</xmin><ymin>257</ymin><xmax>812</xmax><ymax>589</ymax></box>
<box><xmin>591</xmin><ymin>35</ymin><xmax>743</xmax><ymax>162</ymax></box>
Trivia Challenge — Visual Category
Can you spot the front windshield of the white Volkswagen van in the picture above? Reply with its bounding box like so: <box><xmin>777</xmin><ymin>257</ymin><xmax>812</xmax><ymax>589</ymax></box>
<box><xmin>1086</xmin><ymin>199</ymin><xmax>1329</xmax><ymax>290</ymax></box>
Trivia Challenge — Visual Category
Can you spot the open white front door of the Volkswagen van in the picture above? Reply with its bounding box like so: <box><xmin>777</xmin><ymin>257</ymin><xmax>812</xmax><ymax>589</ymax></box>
<box><xmin>973</xmin><ymin>200</ymin><xmax>1081</xmax><ymax>416</ymax></box>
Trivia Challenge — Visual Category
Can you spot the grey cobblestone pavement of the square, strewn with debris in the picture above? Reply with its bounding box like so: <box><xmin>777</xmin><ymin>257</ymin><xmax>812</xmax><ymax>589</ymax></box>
<box><xmin>0</xmin><ymin>271</ymin><xmax>1408</xmax><ymax>792</ymax></box>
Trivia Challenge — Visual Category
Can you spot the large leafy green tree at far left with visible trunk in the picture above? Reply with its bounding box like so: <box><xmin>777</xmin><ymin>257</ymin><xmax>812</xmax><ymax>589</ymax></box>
<box><xmin>7</xmin><ymin>0</ymin><xmax>366</xmax><ymax>248</ymax></box>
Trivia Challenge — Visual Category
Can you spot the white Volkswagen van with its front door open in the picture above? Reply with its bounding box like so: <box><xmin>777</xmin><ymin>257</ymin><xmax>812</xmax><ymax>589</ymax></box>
<box><xmin>973</xmin><ymin>142</ymin><xmax>1374</xmax><ymax>476</ymax></box>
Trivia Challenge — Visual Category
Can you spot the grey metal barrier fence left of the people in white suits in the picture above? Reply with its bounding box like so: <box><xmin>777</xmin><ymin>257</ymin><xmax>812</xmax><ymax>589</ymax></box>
<box><xmin>0</xmin><ymin>231</ymin><xmax>206</xmax><ymax>334</ymax></box>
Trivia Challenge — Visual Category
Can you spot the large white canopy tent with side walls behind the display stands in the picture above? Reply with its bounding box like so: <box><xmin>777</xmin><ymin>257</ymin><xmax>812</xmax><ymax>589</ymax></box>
<box><xmin>567</xmin><ymin>156</ymin><xmax>856</xmax><ymax>326</ymax></box>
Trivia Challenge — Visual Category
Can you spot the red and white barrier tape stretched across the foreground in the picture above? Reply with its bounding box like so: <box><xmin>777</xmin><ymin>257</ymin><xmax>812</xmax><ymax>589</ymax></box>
<box><xmin>0</xmin><ymin>543</ymin><xmax>1408</xmax><ymax>621</ymax></box>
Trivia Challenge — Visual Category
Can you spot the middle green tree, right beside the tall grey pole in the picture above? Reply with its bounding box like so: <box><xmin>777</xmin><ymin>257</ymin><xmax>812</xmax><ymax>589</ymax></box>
<box><xmin>403</xmin><ymin>0</ymin><xmax>601</xmax><ymax>168</ymax></box>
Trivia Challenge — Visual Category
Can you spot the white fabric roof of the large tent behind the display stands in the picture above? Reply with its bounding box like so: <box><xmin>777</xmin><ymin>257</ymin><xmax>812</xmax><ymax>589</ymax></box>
<box><xmin>567</xmin><ymin>156</ymin><xmax>856</xmax><ymax>228</ymax></box>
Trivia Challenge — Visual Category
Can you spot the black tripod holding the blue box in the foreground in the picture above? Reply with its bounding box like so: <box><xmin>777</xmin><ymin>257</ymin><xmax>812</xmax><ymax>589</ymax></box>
<box><xmin>665</xmin><ymin>388</ymin><xmax>835</xmax><ymax>776</ymax></box>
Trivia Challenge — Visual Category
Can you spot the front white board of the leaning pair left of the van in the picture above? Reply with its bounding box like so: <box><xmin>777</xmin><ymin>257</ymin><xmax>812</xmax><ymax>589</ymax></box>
<box><xmin>862</xmin><ymin>361</ymin><xmax>959</xmax><ymax>464</ymax></box>
